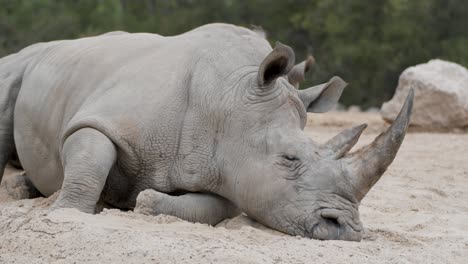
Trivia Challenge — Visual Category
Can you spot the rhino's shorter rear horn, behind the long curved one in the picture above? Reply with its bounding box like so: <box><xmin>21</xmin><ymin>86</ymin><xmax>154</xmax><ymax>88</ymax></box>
<box><xmin>322</xmin><ymin>124</ymin><xmax>367</xmax><ymax>159</ymax></box>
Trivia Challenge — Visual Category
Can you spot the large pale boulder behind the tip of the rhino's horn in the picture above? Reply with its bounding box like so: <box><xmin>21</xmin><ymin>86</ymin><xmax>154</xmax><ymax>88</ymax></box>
<box><xmin>381</xmin><ymin>59</ymin><xmax>468</xmax><ymax>130</ymax></box>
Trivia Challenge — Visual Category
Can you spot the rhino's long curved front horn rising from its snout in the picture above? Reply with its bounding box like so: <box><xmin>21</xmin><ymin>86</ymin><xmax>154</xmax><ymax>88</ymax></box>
<box><xmin>342</xmin><ymin>90</ymin><xmax>414</xmax><ymax>201</ymax></box>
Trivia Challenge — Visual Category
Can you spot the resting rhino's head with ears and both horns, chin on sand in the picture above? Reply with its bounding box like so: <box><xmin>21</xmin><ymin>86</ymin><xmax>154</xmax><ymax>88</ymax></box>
<box><xmin>217</xmin><ymin>43</ymin><xmax>413</xmax><ymax>241</ymax></box>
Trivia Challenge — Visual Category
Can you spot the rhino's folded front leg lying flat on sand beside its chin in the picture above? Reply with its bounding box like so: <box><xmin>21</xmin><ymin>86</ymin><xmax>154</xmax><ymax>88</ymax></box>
<box><xmin>135</xmin><ymin>189</ymin><xmax>241</xmax><ymax>225</ymax></box>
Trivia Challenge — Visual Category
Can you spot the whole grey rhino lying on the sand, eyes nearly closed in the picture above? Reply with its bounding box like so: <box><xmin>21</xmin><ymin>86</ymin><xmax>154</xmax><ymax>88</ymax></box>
<box><xmin>0</xmin><ymin>24</ymin><xmax>412</xmax><ymax>241</ymax></box>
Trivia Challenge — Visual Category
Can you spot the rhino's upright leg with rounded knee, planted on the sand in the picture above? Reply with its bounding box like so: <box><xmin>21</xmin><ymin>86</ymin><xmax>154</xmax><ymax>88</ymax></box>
<box><xmin>52</xmin><ymin>128</ymin><xmax>117</xmax><ymax>213</ymax></box>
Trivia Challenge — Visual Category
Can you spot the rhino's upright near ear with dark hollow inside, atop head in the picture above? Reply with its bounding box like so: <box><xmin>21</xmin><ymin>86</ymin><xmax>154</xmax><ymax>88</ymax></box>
<box><xmin>257</xmin><ymin>42</ymin><xmax>295</xmax><ymax>86</ymax></box>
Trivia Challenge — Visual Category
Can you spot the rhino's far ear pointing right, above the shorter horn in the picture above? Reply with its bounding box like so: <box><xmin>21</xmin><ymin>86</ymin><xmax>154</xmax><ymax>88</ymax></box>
<box><xmin>298</xmin><ymin>76</ymin><xmax>348</xmax><ymax>113</ymax></box>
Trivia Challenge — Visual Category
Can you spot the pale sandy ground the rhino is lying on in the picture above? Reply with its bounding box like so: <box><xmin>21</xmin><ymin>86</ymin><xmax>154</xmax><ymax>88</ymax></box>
<box><xmin>0</xmin><ymin>113</ymin><xmax>468</xmax><ymax>264</ymax></box>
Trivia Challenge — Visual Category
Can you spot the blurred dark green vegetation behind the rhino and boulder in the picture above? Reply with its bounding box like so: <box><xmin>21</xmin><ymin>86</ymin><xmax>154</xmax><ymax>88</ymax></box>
<box><xmin>0</xmin><ymin>0</ymin><xmax>468</xmax><ymax>107</ymax></box>
